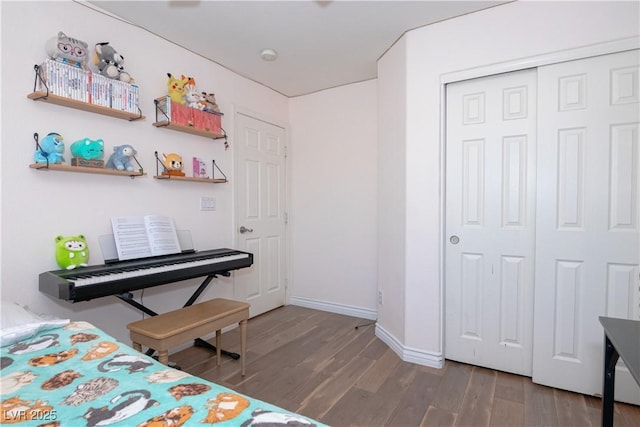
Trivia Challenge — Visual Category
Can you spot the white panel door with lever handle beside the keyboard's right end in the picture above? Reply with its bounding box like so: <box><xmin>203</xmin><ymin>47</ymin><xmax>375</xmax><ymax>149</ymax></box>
<box><xmin>234</xmin><ymin>113</ymin><xmax>287</xmax><ymax>316</ymax></box>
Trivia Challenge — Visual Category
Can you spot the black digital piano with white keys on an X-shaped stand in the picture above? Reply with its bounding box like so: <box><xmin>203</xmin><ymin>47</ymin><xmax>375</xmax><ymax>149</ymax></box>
<box><xmin>39</xmin><ymin>248</ymin><xmax>253</xmax><ymax>302</ymax></box>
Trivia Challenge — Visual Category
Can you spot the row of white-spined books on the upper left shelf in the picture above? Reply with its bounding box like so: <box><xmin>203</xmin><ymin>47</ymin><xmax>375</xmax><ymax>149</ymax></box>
<box><xmin>37</xmin><ymin>59</ymin><xmax>140</xmax><ymax>113</ymax></box>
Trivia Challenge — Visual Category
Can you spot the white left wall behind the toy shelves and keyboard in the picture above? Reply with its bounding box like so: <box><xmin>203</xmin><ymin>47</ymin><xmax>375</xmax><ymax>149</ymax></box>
<box><xmin>0</xmin><ymin>1</ymin><xmax>289</xmax><ymax>340</ymax></box>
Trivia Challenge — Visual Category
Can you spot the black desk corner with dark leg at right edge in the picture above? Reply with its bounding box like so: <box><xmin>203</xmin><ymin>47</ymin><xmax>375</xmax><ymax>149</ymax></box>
<box><xmin>600</xmin><ymin>316</ymin><xmax>640</xmax><ymax>427</ymax></box>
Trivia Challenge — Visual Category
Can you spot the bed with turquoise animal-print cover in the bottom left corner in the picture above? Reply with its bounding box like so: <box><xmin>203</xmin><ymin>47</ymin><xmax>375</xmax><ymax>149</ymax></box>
<box><xmin>0</xmin><ymin>302</ymin><xmax>323</xmax><ymax>427</ymax></box>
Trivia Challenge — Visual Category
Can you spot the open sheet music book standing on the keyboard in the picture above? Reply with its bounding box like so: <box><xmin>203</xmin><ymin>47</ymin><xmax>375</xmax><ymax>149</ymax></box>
<box><xmin>111</xmin><ymin>215</ymin><xmax>181</xmax><ymax>261</ymax></box>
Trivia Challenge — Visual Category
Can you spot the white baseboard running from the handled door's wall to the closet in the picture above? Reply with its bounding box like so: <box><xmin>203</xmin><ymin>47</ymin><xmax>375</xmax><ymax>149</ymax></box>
<box><xmin>289</xmin><ymin>297</ymin><xmax>444</xmax><ymax>369</ymax></box>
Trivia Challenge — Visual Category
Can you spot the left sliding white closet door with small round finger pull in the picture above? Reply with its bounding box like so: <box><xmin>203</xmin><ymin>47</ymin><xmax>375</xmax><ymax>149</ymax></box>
<box><xmin>445</xmin><ymin>70</ymin><xmax>536</xmax><ymax>375</ymax></box>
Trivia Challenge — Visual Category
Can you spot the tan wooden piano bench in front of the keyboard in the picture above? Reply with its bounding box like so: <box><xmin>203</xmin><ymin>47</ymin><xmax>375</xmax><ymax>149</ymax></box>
<box><xmin>127</xmin><ymin>298</ymin><xmax>249</xmax><ymax>376</ymax></box>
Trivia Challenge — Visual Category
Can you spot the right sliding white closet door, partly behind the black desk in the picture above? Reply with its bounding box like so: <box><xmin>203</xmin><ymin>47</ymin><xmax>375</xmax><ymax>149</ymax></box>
<box><xmin>533</xmin><ymin>50</ymin><xmax>640</xmax><ymax>403</ymax></box>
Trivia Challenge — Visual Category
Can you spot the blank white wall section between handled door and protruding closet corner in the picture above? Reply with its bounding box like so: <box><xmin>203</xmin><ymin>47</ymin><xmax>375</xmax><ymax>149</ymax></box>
<box><xmin>289</xmin><ymin>80</ymin><xmax>377</xmax><ymax>318</ymax></box>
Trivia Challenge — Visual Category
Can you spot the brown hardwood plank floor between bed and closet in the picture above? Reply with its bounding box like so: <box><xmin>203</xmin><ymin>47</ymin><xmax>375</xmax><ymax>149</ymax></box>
<box><xmin>170</xmin><ymin>306</ymin><xmax>640</xmax><ymax>427</ymax></box>
